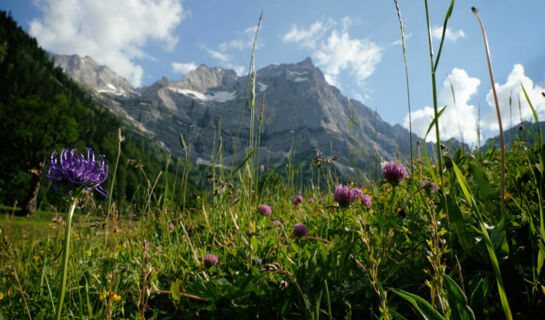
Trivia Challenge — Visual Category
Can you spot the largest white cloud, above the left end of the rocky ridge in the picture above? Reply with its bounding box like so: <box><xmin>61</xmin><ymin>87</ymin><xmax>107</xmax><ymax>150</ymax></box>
<box><xmin>30</xmin><ymin>0</ymin><xmax>183</xmax><ymax>86</ymax></box>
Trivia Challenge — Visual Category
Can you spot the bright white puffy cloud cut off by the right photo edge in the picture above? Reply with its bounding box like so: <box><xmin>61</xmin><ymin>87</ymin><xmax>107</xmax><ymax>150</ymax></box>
<box><xmin>482</xmin><ymin>64</ymin><xmax>545</xmax><ymax>133</ymax></box>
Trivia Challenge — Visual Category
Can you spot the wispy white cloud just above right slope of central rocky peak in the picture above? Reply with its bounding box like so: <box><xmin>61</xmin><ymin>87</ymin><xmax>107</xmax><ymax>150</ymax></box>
<box><xmin>282</xmin><ymin>17</ymin><xmax>382</xmax><ymax>88</ymax></box>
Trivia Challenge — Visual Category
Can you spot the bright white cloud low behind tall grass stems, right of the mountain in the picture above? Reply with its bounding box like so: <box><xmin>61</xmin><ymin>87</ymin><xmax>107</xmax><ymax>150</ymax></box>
<box><xmin>404</xmin><ymin>68</ymin><xmax>481</xmax><ymax>144</ymax></box>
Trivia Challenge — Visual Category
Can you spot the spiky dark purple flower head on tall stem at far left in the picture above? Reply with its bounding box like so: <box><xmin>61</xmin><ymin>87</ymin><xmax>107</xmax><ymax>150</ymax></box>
<box><xmin>44</xmin><ymin>148</ymin><xmax>108</xmax><ymax>198</ymax></box>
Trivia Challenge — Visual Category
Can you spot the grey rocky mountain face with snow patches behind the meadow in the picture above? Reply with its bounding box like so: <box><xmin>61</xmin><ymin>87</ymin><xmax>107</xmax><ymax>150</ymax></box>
<box><xmin>56</xmin><ymin>56</ymin><xmax>417</xmax><ymax>174</ymax></box>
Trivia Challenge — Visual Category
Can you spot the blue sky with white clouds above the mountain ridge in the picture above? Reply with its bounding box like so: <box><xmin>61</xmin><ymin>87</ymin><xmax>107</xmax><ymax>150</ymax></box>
<box><xmin>0</xmin><ymin>0</ymin><xmax>545</xmax><ymax>144</ymax></box>
